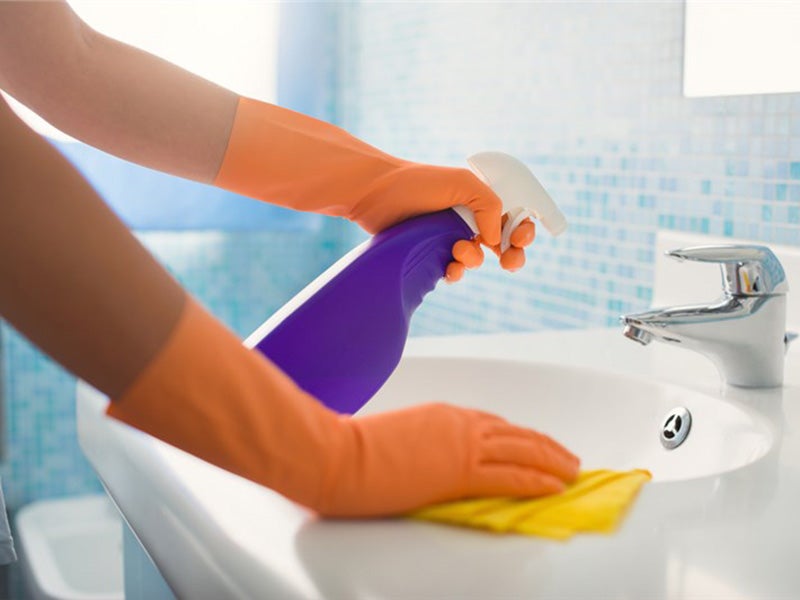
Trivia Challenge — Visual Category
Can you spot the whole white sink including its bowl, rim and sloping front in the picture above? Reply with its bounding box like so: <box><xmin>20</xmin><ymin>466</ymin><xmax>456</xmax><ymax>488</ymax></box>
<box><xmin>78</xmin><ymin>236</ymin><xmax>800</xmax><ymax>600</ymax></box>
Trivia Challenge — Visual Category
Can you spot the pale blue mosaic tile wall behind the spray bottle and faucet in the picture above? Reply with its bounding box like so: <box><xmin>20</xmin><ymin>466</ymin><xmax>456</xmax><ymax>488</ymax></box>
<box><xmin>337</xmin><ymin>2</ymin><xmax>800</xmax><ymax>334</ymax></box>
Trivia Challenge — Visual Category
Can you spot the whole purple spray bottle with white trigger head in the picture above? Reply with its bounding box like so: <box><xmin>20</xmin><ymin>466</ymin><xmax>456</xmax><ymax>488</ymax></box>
<box><xmin>245</xmin><ymin>152</ymin><xmax>567</xmax><ymax>414</ymax></box>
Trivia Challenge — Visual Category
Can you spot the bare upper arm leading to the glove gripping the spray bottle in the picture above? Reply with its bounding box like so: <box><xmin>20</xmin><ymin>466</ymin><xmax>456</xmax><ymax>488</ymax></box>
<box><xmin>0</xmin><ymin>0</ymin><xmax>238</xmax><ymax>183</ymax></box>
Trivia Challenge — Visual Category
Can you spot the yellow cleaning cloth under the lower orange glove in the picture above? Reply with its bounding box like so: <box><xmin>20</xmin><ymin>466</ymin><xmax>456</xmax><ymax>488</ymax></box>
<box><xmin>409</xmin><ymin>469</ymin><xmax>652</xmax><ymax>540</ymax></box>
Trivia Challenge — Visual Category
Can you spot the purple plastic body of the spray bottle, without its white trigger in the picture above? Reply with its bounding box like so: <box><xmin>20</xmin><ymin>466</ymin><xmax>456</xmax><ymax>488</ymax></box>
<box><xmin>255</xmin><ymin>209</ymin><xmax>474</xmax><ymax>414</ymax></box>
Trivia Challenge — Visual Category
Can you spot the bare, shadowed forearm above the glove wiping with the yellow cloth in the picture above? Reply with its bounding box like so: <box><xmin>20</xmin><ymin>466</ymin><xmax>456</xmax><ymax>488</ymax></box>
<box><xmin>0</xmin><ymin>99</ymin><xmax>185</xmax><ymax>396</ymax></box>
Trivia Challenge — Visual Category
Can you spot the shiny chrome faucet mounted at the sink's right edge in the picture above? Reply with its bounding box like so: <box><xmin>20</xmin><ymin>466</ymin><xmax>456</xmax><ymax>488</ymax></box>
<box><xmin>621</xmin><ymin>245</ymin><xmax>796</xmax><ymax>387</ymax></box>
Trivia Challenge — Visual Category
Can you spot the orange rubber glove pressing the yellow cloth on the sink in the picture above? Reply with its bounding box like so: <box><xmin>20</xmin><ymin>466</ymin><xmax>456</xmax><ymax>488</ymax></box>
<box><xmin>107</xmin><ymin>298</ymin><xmax>578</xmax><ymax>517</ymax></box>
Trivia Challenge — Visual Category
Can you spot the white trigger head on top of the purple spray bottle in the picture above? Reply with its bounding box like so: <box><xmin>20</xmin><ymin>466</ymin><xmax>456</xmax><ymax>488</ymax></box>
<box><xmin>467</xmin><ymin>152</ymin><xmax>567</xmax><ymax>252</ymax></box>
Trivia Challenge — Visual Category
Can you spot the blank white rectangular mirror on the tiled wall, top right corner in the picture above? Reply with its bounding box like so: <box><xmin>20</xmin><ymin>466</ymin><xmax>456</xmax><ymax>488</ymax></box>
<box><xmin>683</xmin><ymin>0</ymin><xmax>800</xmax><ymax>97</ymax></box>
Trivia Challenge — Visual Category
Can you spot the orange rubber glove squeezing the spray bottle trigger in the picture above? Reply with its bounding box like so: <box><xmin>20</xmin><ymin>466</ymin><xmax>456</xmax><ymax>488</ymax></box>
<box><xmin>214</xmin><ymin>98</ymin><xmax>533</xmax><ymax>281</ymax></box>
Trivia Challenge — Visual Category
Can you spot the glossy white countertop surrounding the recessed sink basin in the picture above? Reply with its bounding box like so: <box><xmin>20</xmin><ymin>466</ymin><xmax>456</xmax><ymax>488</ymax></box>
<box><xmin>79</xmin><ymin>329</ymin><xmax>800</xmax><ymax>600</ymax></box>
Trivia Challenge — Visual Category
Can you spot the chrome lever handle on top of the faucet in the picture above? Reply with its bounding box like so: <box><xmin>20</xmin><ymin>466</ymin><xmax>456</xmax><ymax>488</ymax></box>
<box><xmin>667</xmin><ymin>244</ymin><xmax>789</xmax><ymax>296</ymax></box>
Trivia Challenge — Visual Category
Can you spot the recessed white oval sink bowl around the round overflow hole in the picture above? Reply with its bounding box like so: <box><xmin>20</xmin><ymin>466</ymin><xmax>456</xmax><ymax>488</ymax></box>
<box><xmin>363</xmin><ymin>357</ymin><xmax>773</xmax><ymax>481</ymax></box>
